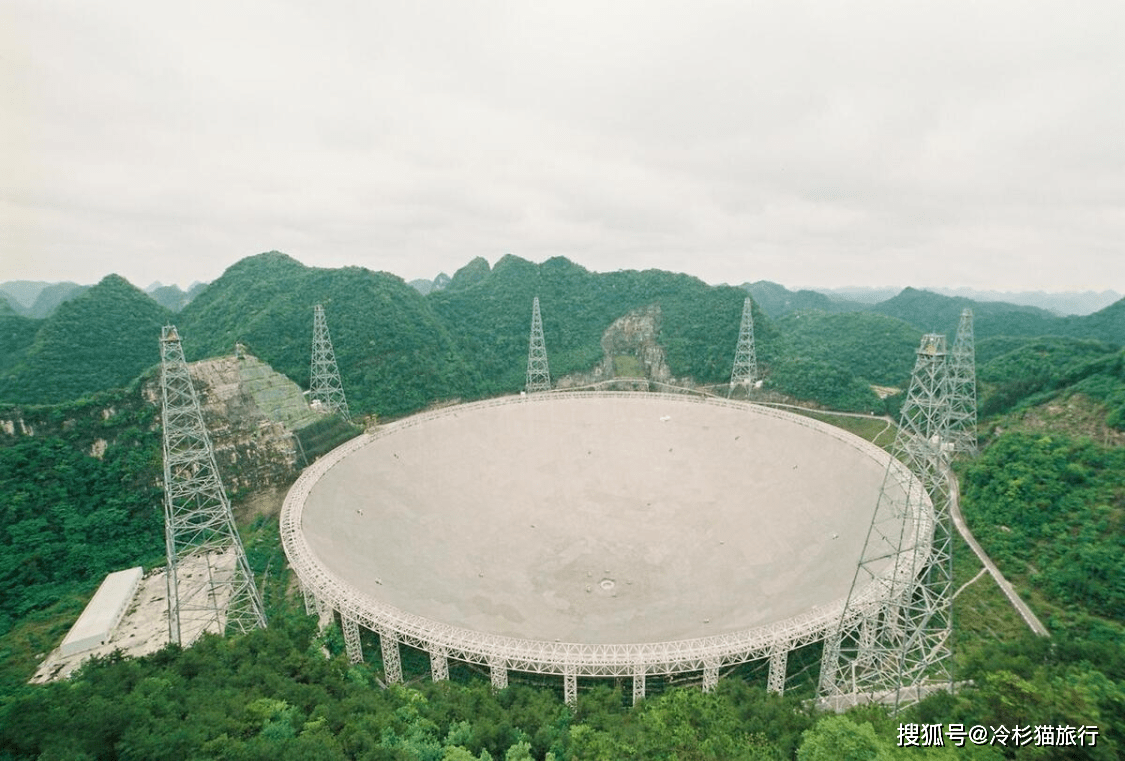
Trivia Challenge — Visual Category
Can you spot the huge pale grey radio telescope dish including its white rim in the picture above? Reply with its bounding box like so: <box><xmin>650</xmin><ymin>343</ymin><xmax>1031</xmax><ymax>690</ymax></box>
<box><xmin>281</xmin><ymin>392</ymin><xmax>933</xmax><ymax>695</ymax></box>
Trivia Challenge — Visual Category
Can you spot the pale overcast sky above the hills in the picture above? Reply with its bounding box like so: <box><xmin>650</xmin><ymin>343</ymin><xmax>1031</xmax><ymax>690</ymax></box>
<box><xmin>0</xmin><ymin>0</ymin><xmax>1125</xmax><ymax>292</ymax></box>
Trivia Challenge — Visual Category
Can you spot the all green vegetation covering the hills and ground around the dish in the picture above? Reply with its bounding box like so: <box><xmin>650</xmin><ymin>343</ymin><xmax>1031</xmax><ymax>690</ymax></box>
<box><xmin>0</xmin><ymin>253</ymin><xmax>1125</xmax><ymax>761</ymax></box>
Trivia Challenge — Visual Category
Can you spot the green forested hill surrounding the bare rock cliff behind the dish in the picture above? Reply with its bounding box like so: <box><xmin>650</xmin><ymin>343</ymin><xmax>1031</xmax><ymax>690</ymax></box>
<box><xmin>426</xmin><ymin>256</ymin><xmax>776</xmax><ymax>395</ymax></box>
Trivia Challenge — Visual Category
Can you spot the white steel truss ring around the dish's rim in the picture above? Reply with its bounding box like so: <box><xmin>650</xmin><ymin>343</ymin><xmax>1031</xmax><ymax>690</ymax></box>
<box><xmin>280</xmin><ymin>392</ymin><xmax>932</xmax><ymax>700</ymax></box>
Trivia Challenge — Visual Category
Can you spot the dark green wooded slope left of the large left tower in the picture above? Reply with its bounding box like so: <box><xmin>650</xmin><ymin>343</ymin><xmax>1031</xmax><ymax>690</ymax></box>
<box><xmin>0</xmin><ymin>385</ymin><xmax>163</xmax><ymax>635</ymax></box>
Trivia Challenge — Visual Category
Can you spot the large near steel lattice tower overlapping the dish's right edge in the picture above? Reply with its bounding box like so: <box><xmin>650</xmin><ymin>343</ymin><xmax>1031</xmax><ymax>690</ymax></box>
<box><xmin>820</xmin><ymin>334</ymin><xmax>953</xmax><ymax>707</ymax></box>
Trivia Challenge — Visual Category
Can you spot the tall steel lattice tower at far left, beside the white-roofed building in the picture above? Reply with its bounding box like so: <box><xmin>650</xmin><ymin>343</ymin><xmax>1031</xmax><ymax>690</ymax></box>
<box><xmin>160</xmin><ymin>325</ymin><xmax>266</xmax><ymax>645</ymax></box>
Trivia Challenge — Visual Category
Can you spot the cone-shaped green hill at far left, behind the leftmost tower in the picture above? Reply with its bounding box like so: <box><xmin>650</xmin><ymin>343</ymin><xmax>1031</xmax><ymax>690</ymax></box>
<box><xmin>0</xmin><ymin>275</ymin><xmax>171</xmax><ymax>404</ymax></box>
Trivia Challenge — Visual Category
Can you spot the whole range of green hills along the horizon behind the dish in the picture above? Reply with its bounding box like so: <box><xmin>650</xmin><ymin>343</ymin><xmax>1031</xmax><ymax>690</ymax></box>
<box><xmin>0</xmin><ymin>251</ymin><xmax>1125</xmax><ymax>415</ymax></box>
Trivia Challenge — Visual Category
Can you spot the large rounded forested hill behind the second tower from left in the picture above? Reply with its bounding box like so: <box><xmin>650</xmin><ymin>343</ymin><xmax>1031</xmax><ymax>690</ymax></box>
<box><xmin>177</xmin><ymin>252</ymin><xmax>475</xmax><ymax>415</ymax></box>
